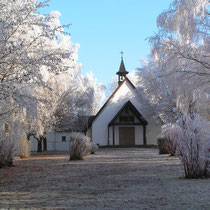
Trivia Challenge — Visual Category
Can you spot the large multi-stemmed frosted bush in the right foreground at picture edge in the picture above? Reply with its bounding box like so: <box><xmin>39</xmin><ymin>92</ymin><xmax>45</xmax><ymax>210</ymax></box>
<box><xmin>163</xmin><ymin>114</ymin><xmax>210</xmax><ymax>178</ymax></box>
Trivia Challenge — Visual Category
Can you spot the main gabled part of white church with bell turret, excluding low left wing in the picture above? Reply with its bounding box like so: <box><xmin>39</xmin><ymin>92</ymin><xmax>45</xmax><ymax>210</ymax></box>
<box><xmin>87</xmin><ymin>57</ymin><xmax>161</xmax><ymax>147</ymax></box>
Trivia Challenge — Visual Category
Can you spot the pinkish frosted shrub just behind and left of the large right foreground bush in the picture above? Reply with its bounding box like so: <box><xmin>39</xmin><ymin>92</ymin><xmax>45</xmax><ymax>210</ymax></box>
<box><xmin>162</xmin><ymin>124</ymin><xmax>181</xmax><ymax>156</ymax></box>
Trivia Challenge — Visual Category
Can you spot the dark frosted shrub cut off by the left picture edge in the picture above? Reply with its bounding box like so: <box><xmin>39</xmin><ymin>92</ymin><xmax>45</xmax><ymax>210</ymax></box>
<box><xmin>0</xmin><ymin>138</ymin><xmax>16</xmax><ymax>168</ymax></box>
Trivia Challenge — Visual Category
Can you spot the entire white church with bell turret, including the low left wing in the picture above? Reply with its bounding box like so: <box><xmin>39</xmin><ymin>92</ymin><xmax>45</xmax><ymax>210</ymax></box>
<box><xmin>31</xmin><ymin>57</ymin><xmax>161</xmax><ymax>151</ymax></box>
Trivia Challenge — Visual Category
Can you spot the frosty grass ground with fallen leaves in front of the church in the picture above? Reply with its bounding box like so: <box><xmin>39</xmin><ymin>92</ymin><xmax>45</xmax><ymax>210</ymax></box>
<box><xmin>0</xmin><ymin>148</ymin><xmax>210</xmax><ymax>209</ymax></box>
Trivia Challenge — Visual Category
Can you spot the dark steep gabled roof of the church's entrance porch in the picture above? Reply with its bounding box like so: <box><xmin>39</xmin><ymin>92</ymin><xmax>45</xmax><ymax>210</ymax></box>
<box><xmin>109</xmin><ymin>100</ymin><xmax>148</xmax><ymax>126</ymax></box>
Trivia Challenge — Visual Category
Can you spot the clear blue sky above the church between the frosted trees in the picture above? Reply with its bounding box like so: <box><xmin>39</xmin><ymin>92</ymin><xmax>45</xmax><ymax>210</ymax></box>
<box><xmin>42</xmin><ymin>0</ymin><xmax>172</xmax><ymax>85</ymax></box>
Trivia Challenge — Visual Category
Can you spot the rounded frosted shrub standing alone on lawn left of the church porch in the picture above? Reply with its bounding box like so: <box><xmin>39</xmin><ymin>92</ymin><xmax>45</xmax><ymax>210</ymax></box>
<box><xmin>70</xmin><ymin>133</ymin><xmax>90</xmax><ymax>160</ymax></box>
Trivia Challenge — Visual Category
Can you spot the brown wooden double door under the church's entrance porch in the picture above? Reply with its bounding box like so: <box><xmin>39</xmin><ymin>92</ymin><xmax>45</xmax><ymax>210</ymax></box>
<box><xmin>119</xmin><ymin>127</ymin><xmax>135</xmax><ymax>146</ymax></box>
